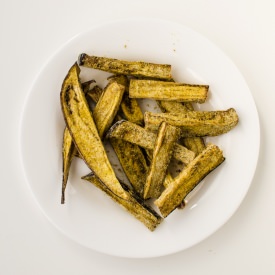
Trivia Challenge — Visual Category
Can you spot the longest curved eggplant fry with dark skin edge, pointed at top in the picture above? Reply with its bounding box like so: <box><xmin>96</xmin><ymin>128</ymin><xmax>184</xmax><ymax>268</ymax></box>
<box><xmin>60</xmin><ymin>63</ymin><xmax>128</xmax><ymax>200</ymax></box>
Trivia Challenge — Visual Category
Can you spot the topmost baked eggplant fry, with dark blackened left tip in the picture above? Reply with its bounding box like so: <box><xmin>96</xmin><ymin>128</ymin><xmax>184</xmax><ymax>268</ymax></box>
<box><xmin>78</xmin><ymin>53</ymin><xmax>172</xmax><ymax>79</ymax></box>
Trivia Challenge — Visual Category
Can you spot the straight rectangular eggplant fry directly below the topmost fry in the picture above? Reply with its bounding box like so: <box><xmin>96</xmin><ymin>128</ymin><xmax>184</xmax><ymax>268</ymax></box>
<box><xmin>129</xmin><ymin>79</ymin><xmax>209</xmax><ymax>103</ymax></box>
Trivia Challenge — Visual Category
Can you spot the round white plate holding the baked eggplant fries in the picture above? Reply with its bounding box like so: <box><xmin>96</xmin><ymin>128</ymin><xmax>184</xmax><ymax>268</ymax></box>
<box><xmin>21</xmin><ymin>19</ymin><xmax>260</xmax><ymax>258</ymax></box>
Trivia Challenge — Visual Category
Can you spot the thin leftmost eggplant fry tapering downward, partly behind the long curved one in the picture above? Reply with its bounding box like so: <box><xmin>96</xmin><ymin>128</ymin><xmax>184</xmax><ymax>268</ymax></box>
<box><xmin>61</xmin><ymin>127</ymin><xmax>77</xmax><ymax>204</ymax></box>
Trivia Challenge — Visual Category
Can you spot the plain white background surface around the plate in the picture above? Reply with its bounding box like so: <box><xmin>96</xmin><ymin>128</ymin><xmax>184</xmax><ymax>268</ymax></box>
<box><xmin>0</xmin><ymin>0</ymin><xmax>275</xmax><ymax>275</ymax></box>
